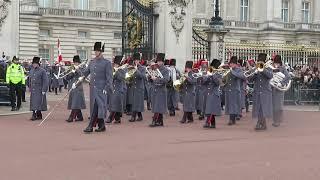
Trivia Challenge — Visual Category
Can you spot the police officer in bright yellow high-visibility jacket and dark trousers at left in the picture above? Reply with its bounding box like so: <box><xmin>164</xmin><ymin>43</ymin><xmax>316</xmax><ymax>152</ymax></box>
<box><xmin>6</xmin><ymin>56</ymin><xmax>25</xmax><ymax>111</ymax></box>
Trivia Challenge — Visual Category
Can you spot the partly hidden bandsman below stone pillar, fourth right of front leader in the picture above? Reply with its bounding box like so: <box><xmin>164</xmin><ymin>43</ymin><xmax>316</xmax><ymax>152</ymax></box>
<box><xmin>167</xmin><ymin>59</ymin><xmax>180</xmax><ymax>116</ymax></box>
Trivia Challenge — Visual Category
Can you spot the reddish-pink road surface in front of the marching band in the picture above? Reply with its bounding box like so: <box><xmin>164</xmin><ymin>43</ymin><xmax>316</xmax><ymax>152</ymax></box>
<box><xmin>0</xmin><ymin>89</ymin><xmax>320</xmax><ymax>180</ymax></box>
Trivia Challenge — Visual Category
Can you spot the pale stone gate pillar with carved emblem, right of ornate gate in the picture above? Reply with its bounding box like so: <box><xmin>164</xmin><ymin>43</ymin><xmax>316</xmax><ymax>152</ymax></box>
<box><xmin>154</xmin><ymin>0</ymin><xmax>192</xmax><ymax>70</ymax></box>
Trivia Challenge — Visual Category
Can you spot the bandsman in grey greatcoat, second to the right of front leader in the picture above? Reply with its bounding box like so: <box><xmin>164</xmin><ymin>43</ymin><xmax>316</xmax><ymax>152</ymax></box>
<box><xmin>129</xmin><ymin>53</ymin><xmax>146</xmax><ymax>122</ymax></box>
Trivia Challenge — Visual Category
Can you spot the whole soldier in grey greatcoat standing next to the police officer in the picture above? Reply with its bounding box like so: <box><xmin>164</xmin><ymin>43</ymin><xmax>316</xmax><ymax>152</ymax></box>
<box><xmin>28</xmin><ymin>57</ymin><xmax>48</xmax><ymax>121</ymax></box>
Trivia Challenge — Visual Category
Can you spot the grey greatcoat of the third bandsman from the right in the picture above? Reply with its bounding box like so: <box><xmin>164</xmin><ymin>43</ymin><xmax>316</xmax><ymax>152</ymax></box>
<box><xmin>224</xmin><ymin>67</ymin><xmax>246</xmax><ymax>114</ymax></box>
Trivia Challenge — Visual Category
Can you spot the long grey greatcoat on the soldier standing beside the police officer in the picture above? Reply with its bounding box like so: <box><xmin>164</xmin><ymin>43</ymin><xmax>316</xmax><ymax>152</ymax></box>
<box><xmin>29</xmin><ymin>67</ymin><xmax>49</xmax><ymax>111</ymax></box>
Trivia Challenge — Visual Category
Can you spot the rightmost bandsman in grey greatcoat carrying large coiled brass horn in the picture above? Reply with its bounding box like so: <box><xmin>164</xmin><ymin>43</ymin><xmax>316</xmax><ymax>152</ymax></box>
<box><xmin>272</xmin><ymin>55</ymin><xmax>291</xmax><ymax>127</ymax></box>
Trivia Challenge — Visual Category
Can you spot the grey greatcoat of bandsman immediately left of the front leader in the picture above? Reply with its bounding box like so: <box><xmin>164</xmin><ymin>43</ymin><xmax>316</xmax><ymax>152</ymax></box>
<box><xmin>66</xmin><ymin>70</ymin><xmax>86</xmax><ymax>109</ymax></box>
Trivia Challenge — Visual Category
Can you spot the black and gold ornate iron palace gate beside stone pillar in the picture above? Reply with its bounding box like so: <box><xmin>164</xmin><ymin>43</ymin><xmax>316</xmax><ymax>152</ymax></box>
<box><xmin>122</xmin><ymin>0</ymin><xmax>153</xmax><ymax>59</ymax></box>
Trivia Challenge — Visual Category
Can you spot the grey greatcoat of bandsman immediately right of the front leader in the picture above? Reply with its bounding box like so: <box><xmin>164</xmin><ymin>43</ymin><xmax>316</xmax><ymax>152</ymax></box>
<box><xmin>109</xmin><ymin>69</ymin><xmax>126</xmax><ymax>112</ymax></box>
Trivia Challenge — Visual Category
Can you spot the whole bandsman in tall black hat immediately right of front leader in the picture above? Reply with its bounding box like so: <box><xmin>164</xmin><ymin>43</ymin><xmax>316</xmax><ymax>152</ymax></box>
<box><xmin>106</xmin><ymin>56</ymin><xmax>126</xmax><ymax>124</ymax></box>
